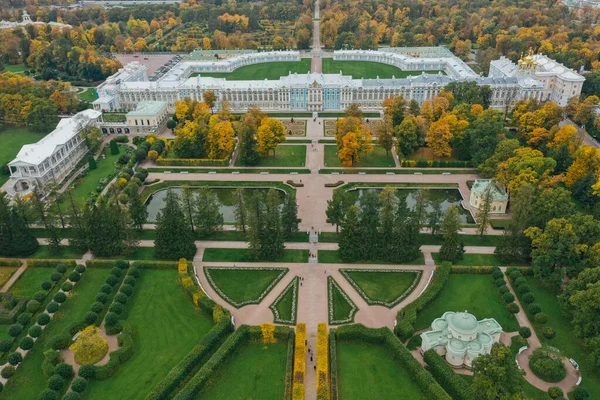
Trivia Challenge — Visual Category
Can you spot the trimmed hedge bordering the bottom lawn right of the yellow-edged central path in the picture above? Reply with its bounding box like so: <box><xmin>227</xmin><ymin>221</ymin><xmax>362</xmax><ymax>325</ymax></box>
<box><xmin>335</xmin><ymin>324</ymin><xmax>452</xmax><ymax>400</ymax></box>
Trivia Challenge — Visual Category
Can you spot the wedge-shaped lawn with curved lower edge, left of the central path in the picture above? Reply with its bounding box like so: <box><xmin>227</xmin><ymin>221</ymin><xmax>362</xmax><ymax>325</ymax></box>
<box><xmin>204</xmin><ymin>267</ymin><xmax>287</xmax><ymax>307</ymax></box>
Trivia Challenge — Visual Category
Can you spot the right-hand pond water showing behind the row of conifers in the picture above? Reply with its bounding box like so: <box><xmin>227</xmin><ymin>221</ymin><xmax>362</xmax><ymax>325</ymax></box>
<box><xmin>348</xmin><ymin>188</ymin><xmax>475</xmax><ymax>224</ymax></box>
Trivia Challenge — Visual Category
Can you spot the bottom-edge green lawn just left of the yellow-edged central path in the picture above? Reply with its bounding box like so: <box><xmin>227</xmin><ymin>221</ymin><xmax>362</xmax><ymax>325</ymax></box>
<box><xmin>196</xmin><ymin>343</ymin><xmax>288</xmax><ymax>400</ymax></box>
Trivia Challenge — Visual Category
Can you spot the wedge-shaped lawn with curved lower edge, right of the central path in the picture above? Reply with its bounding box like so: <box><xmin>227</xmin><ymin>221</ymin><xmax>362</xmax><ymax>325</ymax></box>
<box><xmin>346</xmin><ymin>270</ymin><xmax>419</xmax><ymax>307</ymax></box>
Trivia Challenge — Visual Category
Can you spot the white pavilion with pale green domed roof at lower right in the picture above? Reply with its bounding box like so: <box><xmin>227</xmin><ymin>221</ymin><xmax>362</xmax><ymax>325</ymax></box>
<box><xmin>421</xmin><ymin>311</ymin><xmax>503</xmax><ymax>368</ymax></box>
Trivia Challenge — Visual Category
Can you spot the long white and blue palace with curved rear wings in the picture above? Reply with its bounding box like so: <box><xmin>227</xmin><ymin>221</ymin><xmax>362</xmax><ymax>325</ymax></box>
<box><xmin>93</xmin><ymin>47</ymin><xmax>584</xmax><ymax>112</ymax></box>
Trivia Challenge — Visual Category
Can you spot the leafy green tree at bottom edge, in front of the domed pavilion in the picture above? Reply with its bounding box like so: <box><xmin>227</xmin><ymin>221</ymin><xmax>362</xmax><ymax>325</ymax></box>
<box><xmin>473</xmin><ymin>343</ymin><xmax>523</xmax><ymax>400</ymax></box>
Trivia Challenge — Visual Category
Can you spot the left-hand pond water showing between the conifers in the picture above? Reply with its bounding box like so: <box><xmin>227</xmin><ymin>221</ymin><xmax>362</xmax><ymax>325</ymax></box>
<box><xmin>146</xmin><ymin>187</ymin><xmax>285</xmax><ymax>224</ymax></box>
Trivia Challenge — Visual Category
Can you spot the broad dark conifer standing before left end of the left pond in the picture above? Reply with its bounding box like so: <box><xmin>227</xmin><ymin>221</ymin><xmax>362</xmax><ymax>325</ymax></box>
<box><xmin>154</xmin><ymin>190</ymin><xmax>196</xmax><ymax>260</ymax></box>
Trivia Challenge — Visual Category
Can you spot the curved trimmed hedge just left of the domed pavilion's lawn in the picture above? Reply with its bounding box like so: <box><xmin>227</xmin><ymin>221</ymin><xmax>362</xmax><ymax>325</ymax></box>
<box><xmin>394</xmin><ymin>262</ymin><xmax>452</xmax><ymax>340</ymax></box>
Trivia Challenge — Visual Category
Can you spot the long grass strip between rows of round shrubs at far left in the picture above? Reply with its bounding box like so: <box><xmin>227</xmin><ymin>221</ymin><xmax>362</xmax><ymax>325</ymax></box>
<box><xmin>0</xmin><ymin>268</ymin><xmax>110</xmax><ymax>400</ymax></box>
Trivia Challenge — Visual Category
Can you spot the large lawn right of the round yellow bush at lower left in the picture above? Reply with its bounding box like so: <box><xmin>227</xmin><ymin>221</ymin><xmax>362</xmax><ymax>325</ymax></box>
<box><xmin>87</xmin><ymin>269</ymin><xmax>213</xmax><ymax>400</ymax></box>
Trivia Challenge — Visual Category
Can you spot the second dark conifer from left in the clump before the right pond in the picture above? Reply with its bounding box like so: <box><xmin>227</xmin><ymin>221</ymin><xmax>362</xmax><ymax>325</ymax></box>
<box><xmin>359</xmin><ymin>190</ymin><xmax>379</xmax><ymax>260</ymax></box>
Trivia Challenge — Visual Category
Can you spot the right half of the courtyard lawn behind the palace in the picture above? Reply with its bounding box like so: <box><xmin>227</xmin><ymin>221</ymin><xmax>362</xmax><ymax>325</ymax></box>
<box><xmin>323</xmin><ymin>58</ymin><xmax>438</xmax><ymax>79</ymax></box>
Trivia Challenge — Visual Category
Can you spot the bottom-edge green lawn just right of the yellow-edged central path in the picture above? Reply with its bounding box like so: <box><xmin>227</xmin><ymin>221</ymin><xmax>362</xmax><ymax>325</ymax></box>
<box><xmin>337</xmin><ymin>341</ymin><xmax>425</xmax><ymax>400</ymax></box>
